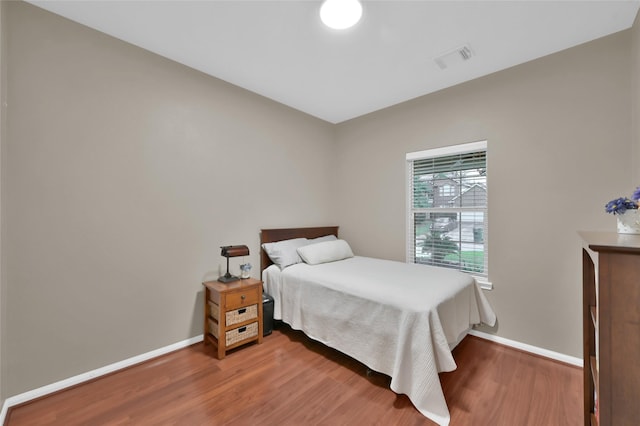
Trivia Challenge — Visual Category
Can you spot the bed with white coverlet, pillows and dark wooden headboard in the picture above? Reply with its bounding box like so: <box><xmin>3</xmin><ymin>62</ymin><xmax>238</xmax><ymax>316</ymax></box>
<box><xmin>260</xmin><ymin>226</ymin><xmax>496</xmax><ymax>425</ymax></box>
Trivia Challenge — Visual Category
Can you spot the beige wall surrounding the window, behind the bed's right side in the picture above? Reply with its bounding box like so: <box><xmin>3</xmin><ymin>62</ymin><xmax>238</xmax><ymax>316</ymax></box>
<box><xmin>337</xmin><ymin>31</ymin><xmax>633</xmax><ymax>357</ymax></box>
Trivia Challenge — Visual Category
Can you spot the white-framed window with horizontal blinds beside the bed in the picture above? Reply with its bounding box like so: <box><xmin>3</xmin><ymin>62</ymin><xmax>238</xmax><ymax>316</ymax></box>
<box><xmin>407</xmin><ymin>141</ymin><xmax>490</xmax><ymax>288</ymax></box>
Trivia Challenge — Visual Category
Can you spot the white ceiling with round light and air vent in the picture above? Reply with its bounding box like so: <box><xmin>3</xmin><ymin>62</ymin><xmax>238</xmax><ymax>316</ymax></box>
<box><xmin>29</xmin><ymin>0</ymin><xmax>640</xmax><ymax>123</ymax></box>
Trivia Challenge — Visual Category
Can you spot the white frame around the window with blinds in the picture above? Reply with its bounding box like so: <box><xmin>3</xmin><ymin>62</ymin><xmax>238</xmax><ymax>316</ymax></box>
<box><xmin>405</xmin><ymin>140</ymin><xmax>493</xmax><ymax>290</ymax></box>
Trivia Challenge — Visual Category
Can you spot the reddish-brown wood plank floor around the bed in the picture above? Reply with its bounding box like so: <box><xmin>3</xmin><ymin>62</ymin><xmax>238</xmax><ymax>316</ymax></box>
<box><xmin>5</xmin><ymin>326</ymin><xmax>582</xmax><ymax>426</ymax></box>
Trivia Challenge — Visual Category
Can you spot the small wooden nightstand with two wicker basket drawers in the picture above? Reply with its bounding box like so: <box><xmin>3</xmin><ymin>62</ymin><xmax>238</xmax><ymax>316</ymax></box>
<box><xmin>202</xmin><ymin>278</ymin><xmax>263</xmax><ymax>359</ymax></box>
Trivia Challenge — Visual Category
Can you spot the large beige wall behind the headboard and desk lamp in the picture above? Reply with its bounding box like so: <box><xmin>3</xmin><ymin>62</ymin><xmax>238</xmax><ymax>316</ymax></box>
<box><xmin>2</xmin><ymin>2</ymin><xmax>335</xmax><ymax>396</ymax></box>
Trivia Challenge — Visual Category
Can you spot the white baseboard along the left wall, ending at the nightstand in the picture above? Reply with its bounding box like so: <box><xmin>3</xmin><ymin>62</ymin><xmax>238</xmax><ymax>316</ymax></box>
<box><xmin>0</xmin><ymin>334</ymin><xmax>203</xmax><ymax>425</ymax></box>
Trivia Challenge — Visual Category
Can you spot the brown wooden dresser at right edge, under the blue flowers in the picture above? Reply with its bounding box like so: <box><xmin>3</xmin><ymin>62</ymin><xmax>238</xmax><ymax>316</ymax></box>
<box><xmin>580</xmin><ymin>232</ymin><xmax>640</xmax><ymax>426</ymax></box>
